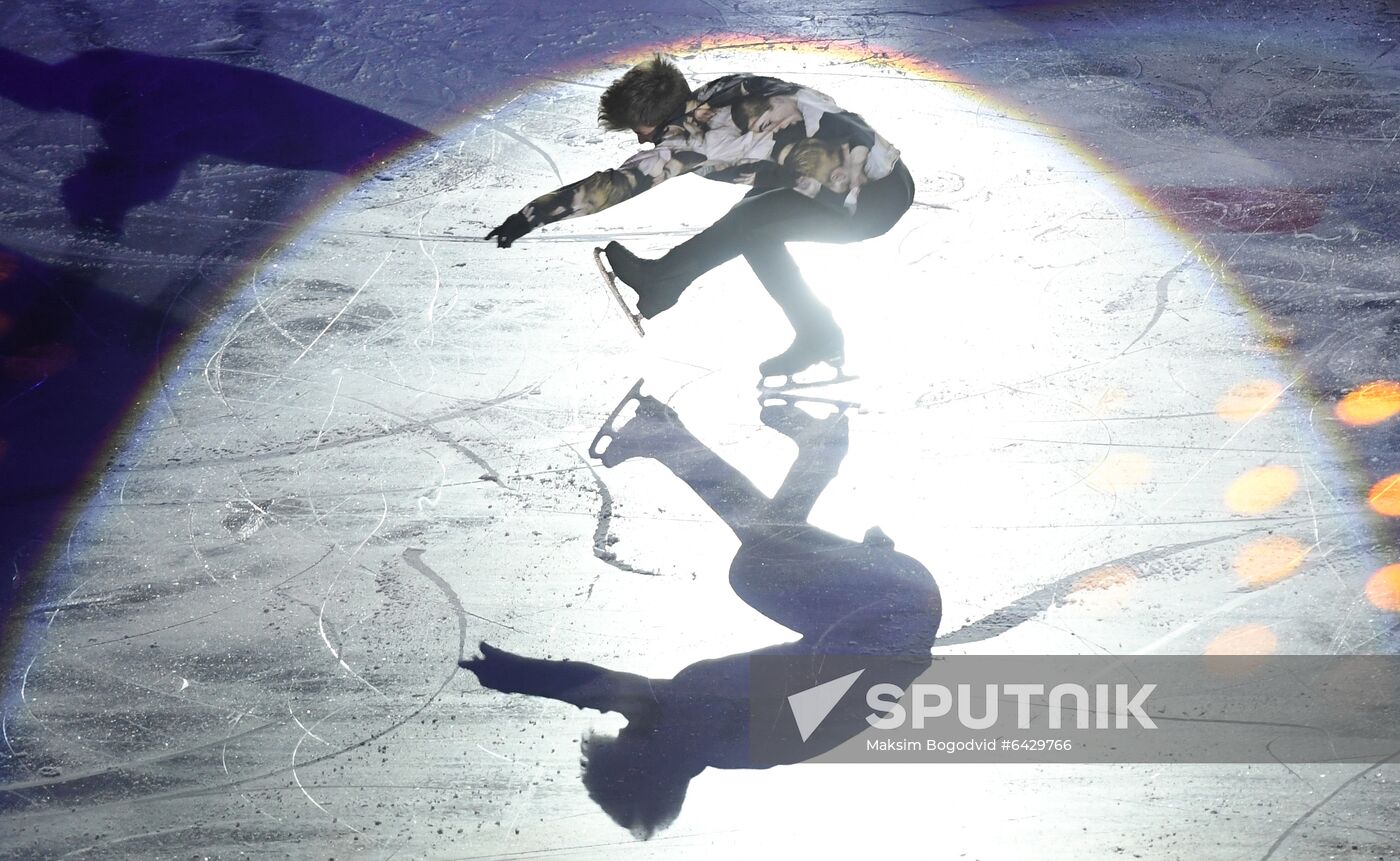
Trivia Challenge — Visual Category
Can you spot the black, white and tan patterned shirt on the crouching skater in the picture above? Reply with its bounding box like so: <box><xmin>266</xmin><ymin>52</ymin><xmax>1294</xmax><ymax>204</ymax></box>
<box><xmin>521</xmin><ymin>74</ymin><xmax>899</xmax><ymax>228</ymax></box>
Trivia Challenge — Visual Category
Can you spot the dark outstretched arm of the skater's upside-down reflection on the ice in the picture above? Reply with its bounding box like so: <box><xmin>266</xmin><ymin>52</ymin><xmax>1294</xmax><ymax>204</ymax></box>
<box><xmin>461</xmin><ymin>643</ymin><xmax>664</xmax><ymax>721</ymax></box>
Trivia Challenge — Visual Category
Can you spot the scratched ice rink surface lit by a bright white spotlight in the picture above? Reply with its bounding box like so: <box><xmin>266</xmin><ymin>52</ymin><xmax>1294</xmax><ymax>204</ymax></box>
<box><xmin>0</xmin><ymin>1</ymin><xmax>1397</xmax><ymax>858</ymax></box>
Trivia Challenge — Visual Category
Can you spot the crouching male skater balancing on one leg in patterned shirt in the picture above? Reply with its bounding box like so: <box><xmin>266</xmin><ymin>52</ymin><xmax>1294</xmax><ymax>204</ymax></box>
<box><xmin>486</xmin><ymin>55</ymin><xmax>914</xmax><ymax>377</ymax></box>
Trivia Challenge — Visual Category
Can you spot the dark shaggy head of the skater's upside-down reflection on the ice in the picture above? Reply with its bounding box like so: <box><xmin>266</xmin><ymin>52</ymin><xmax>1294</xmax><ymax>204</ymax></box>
<box><xmin>582</xmin><ymin>734</ymin><xmax>690</xmax><ymax>840</ymax></box>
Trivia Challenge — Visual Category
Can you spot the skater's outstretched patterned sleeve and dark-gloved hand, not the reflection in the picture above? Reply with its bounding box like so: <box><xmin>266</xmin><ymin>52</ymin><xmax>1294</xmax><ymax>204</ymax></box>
<box><xmin>486</xmin><ymin>141</ymin><xmax>704</xmax><ymax>248</ymax></box>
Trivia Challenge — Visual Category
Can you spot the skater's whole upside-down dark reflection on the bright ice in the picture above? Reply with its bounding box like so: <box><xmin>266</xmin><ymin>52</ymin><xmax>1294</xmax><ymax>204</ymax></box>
<box><xmin>462</xmin><ymin>381</ymin><xmax>941</xmax><ymax>839</ymax></box>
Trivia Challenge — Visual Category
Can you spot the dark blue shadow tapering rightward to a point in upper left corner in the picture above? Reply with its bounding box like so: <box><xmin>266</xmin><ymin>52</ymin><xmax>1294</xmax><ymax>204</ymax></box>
<box><xmin>0</xmin><ymin>48</ymin><xmax>428</xmax><ymax>232</ymax></box>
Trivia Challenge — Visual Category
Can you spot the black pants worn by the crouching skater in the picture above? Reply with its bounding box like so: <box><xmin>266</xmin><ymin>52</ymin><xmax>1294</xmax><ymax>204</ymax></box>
<box><xmin>662</xmin><ymin>161</ymin><xmax>914</xmax><ymax>337</ymax></box>
